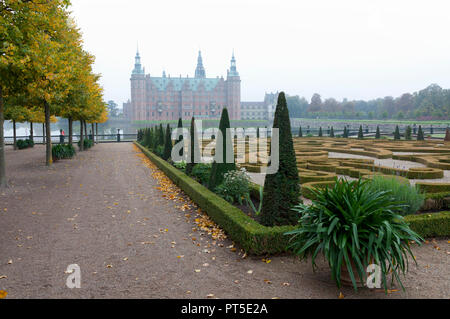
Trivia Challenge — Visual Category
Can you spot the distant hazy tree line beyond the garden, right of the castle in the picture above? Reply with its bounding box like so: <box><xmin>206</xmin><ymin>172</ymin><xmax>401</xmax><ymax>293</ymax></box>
<box><xmin>287</xmin><ymin>84</ymin><xmax>450</xmax><ymax>120</ymax></box>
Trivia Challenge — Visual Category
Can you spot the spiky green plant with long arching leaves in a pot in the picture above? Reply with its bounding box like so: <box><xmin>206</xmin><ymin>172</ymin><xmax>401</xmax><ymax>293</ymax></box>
<box><xmin>287</xmin><ymin>179</ymin><xmax>423</xmax><ymax>291</ymax></box>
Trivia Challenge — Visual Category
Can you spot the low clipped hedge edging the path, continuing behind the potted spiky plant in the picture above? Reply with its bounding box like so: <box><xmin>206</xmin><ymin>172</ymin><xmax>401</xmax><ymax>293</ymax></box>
<box><xmin>134</xmin><ymin>142</ymin><xmax>450</xmax><ymax>255</ymax></box>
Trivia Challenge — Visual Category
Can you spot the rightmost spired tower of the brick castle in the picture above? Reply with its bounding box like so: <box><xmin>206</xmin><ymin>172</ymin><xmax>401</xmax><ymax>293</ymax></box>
<box><xmin>226</xmin><ymin>52</ymin><xmax>241</xmax><ymax>120</ymax></box>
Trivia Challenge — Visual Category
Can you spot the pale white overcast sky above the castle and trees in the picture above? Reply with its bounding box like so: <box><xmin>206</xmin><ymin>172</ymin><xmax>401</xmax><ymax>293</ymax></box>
<box><xmin>72</xmin><ymin>0</ymin><xmax>450</xmax><ymax>107</ymax></box>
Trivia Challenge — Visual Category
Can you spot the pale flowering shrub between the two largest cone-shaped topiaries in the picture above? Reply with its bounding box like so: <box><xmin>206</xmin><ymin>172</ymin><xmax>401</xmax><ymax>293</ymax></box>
<box><xmin>215</xmin><ymin>168</ymin><xmax>250</xmax><ymax>205</ymax></box>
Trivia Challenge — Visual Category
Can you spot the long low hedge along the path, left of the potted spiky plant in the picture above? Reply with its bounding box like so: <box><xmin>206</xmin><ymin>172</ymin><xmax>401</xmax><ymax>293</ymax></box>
<box><xmin>135</xmin><ymin>142</ymin><xmax>295</xmax><ymax>255</ymax></box>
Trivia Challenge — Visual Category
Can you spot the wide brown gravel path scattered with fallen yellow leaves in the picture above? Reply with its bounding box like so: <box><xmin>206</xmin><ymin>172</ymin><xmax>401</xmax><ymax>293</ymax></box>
<box><xmin>0</xmin><ymin>143</ymin><xmax>450</xmax><ymax>298</ymax></box>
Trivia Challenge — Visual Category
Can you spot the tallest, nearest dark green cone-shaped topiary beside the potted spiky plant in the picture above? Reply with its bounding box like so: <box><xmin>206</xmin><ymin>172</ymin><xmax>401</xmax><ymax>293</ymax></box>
<box><xmin>260</xmin><ymin>92</ymin><xmax>300</xmax><ymax>226</ymax></box>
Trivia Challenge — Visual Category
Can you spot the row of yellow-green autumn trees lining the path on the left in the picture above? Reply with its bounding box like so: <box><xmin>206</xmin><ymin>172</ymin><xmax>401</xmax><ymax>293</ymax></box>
<box><xmin>0</xmin><ymin>0</ymin><xmax>107</xmax><ymax>186</ymax></box>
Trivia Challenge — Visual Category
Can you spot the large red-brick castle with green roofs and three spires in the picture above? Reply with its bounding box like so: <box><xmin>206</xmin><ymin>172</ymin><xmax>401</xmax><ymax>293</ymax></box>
<box><xmin>123</xmin><ymin>51</ymin><xmax>241</xmax><ymax>121</ymax></box>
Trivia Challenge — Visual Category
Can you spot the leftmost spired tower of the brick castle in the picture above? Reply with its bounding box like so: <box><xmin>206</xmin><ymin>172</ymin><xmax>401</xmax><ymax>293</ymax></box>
<box><xmin>130</xmin><ymin>50</ymin><xmax>146</xmax><ymax>121</ymax></box>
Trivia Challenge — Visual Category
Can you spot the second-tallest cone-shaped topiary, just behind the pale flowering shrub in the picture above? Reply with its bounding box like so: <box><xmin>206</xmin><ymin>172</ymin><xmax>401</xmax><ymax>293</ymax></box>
<box><xmin>208</xmin><ymin>108</ymin><xmax>236</xmax><ymax>190</ymax></box>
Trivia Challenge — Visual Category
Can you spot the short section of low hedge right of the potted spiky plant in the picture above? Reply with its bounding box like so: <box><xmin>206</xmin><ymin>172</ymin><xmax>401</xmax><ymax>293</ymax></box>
<box><xmin>405</xmin><ymin>212</ymin><xmax>450</xmax><ymax>237</ymax></box>
